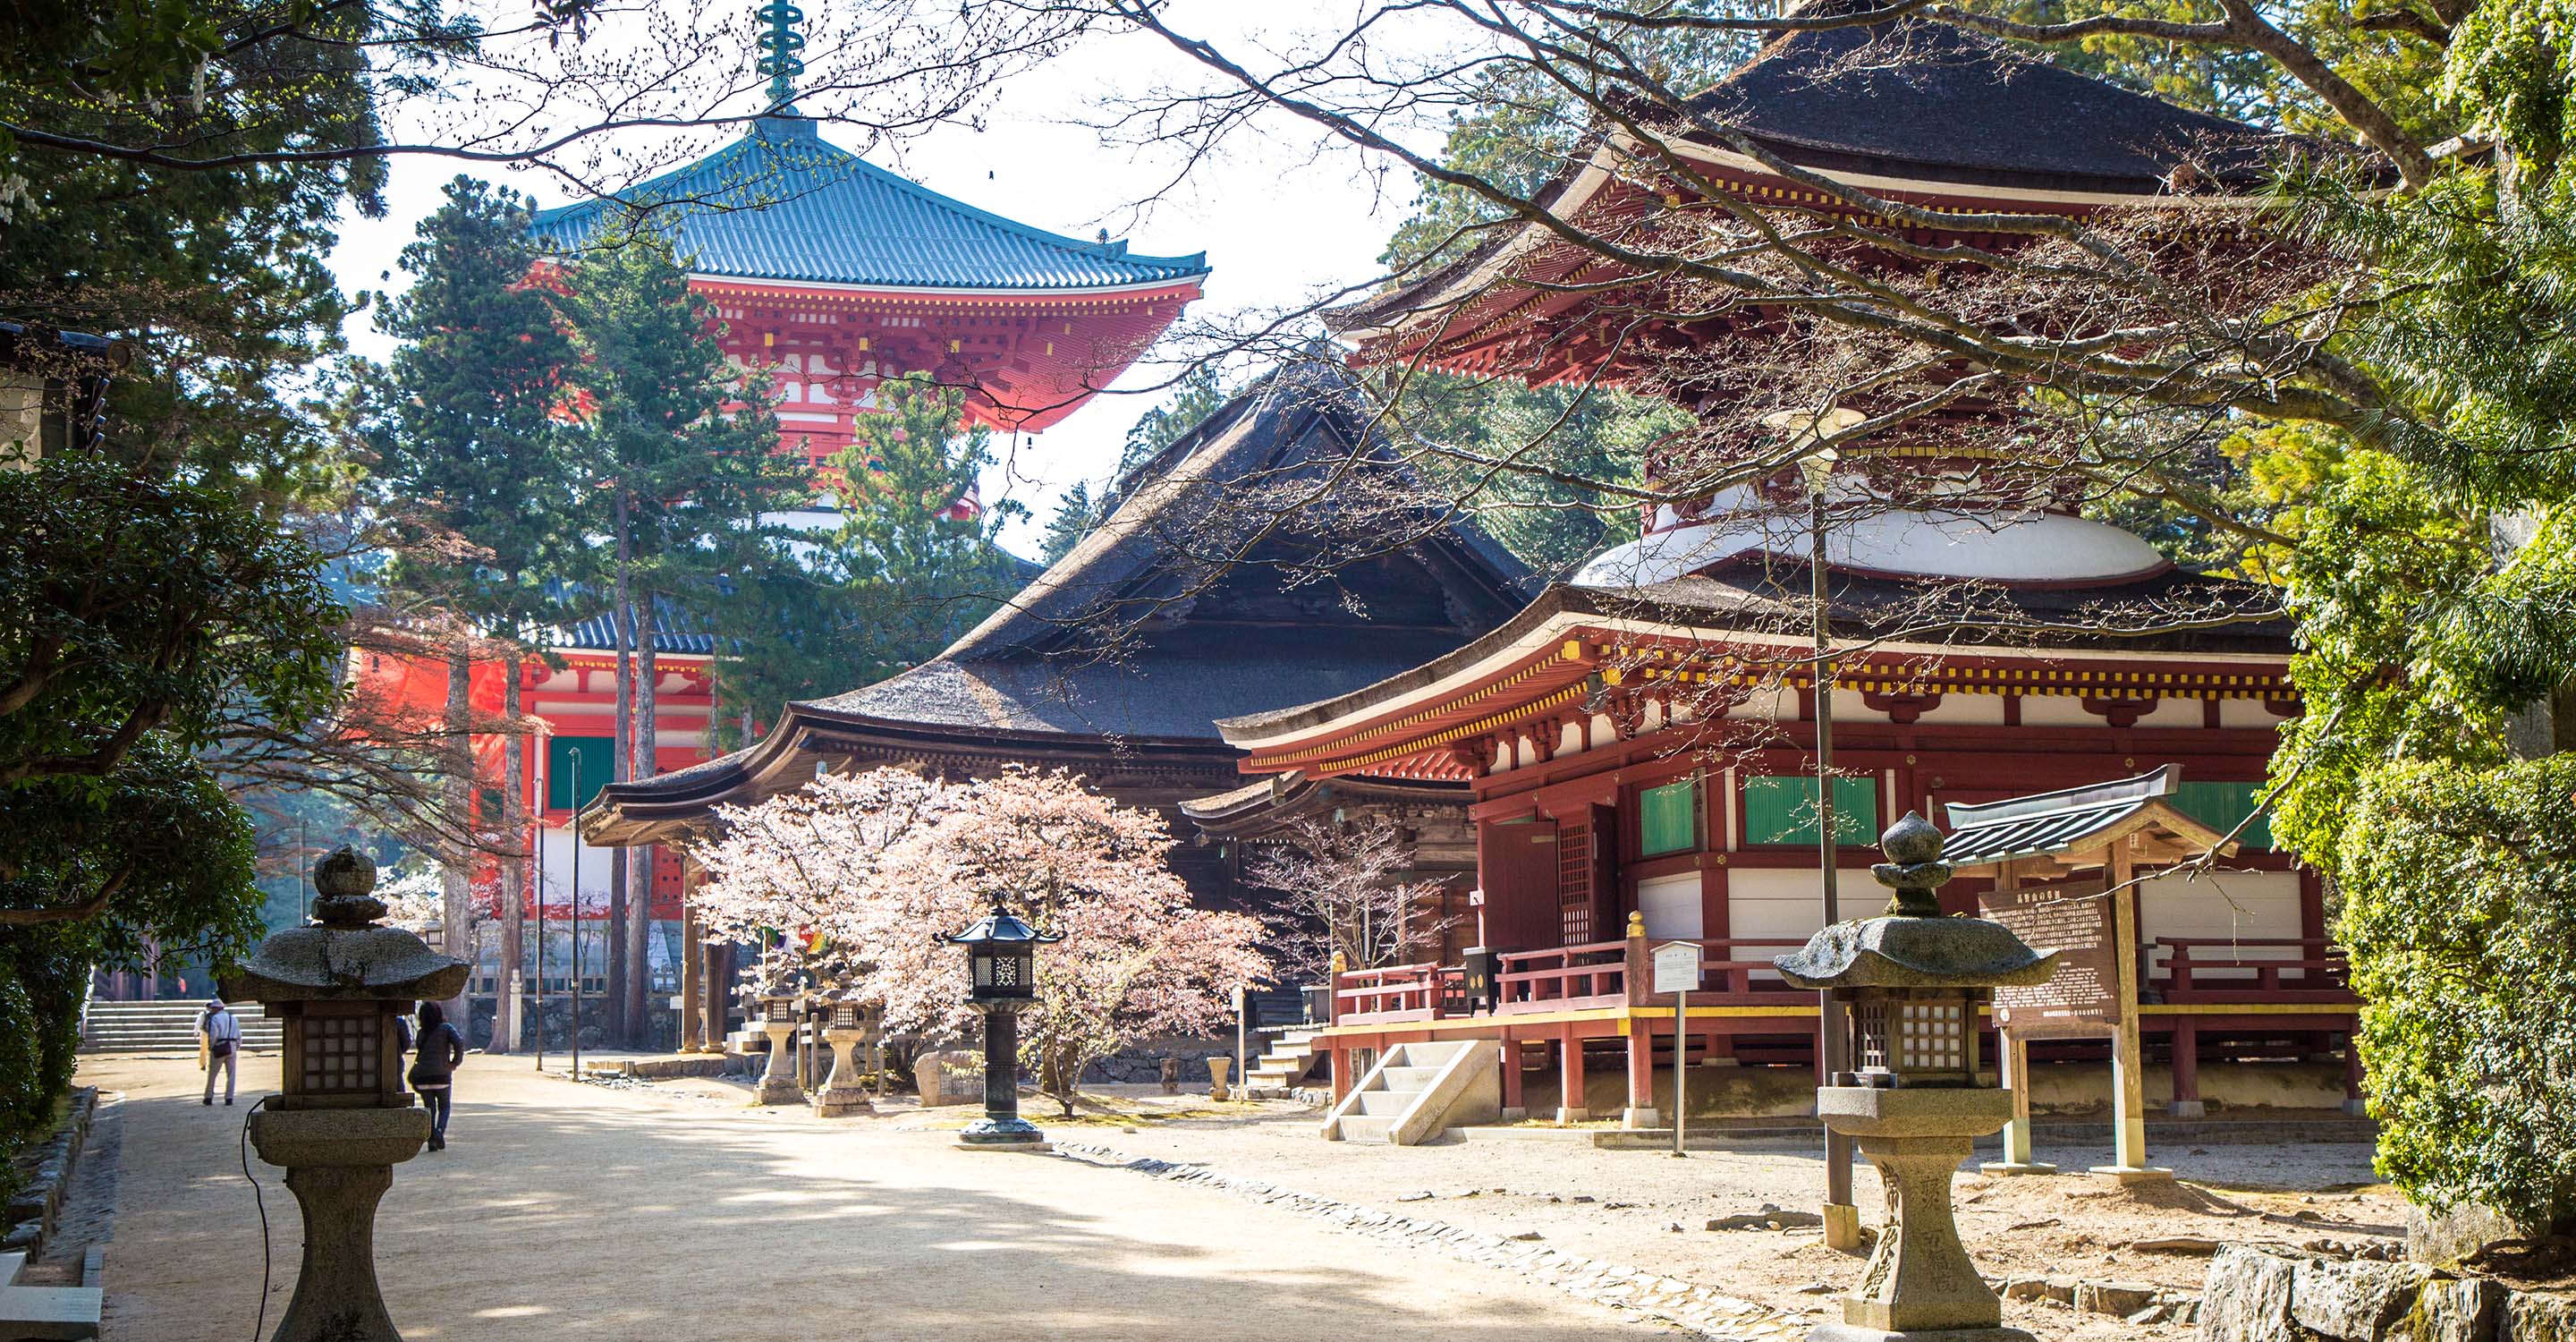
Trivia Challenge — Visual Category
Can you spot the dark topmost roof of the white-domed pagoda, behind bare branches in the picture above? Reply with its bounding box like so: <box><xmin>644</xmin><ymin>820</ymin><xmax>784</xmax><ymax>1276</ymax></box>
<box><xmin>1690</xmin><ymin>0</ymin><xmax>2313</xmax><ymax>196</ymax></box>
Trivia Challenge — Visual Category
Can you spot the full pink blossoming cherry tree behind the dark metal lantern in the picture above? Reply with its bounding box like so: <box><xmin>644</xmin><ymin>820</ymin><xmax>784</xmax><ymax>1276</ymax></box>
<box><xmin>691</xmin><ymin>770</ymin><xmax>1270</xmax><ymax>1113</ymax></box>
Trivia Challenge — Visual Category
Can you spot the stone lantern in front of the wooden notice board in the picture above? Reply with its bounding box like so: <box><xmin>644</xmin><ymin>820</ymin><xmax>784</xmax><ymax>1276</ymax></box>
<box><xmin>1772</xmin><ymin>811</ymin><xmax>2058</xmax><ymax>1342</ymax></box>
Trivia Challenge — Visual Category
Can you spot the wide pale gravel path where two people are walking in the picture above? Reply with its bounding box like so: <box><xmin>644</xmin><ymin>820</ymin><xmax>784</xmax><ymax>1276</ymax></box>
<box><xmin>82</xmin><ymin>1056</ymin><xmax>1662</xmax><ymax>1342</ymax></box>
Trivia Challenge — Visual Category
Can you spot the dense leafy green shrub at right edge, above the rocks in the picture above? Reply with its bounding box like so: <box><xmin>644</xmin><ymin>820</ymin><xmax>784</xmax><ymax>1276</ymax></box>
<box><xmin>2331</xmin><ymin>755</ymin><xmax>2576</xmax><ymax>1228</ymax></box>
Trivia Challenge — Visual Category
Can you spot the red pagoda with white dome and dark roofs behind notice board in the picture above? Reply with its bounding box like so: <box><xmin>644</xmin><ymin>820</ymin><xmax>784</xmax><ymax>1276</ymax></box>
<box><xmin>1221</xmin><ymin>4</ymin><xmax>2350</xmax><ymax>1123</ymax></box>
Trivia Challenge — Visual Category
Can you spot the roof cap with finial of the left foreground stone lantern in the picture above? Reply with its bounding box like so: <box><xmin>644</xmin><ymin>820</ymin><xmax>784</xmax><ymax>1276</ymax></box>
<box><xmin>222</xmin><ymin>847</ymin><xmax>471</xmax><ymax>1002</ymax></box>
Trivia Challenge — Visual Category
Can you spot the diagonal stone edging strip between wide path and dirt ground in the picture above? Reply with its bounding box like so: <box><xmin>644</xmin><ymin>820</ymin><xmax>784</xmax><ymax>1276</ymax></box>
<box><xmin>1056</xmin><ymin>1141</ymin><xmax>1809</xmax><ymax>1342</ymax></box>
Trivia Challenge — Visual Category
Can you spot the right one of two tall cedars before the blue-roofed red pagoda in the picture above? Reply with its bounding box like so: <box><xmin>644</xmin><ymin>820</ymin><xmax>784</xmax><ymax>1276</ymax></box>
<box><xmin>556</xmin><ymin>229</ymin><xmax>809</xmax><ymax>1046</ymax></box>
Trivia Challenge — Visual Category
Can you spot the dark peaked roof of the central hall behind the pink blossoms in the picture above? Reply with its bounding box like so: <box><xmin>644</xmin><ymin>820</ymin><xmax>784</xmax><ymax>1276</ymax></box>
<box><xmin>585</xmin><ymin>363</ymin><xmax>1530</xmax><ymax>842</ymax></box>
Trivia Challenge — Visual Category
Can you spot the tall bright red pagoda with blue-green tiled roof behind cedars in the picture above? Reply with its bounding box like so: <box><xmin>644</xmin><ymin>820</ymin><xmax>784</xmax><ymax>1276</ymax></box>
<box><xmin>358</xmin><ymin>13</ymin><xmax>1208</xmax><ymax>1015</ymax></box>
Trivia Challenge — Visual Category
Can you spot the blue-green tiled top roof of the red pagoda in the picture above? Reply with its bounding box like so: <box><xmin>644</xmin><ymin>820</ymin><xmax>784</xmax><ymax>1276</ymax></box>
<box><xmin>536</xmin><ymin>118</ymin><xmax>1208</xmax><ymax>291</ymax></box>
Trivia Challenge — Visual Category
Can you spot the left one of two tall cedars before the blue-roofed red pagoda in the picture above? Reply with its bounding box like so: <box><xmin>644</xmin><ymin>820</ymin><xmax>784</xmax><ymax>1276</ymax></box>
<box><xmin>371</xmin><ymin>178</ymin><xmax>582</xmax><ymax>1035</ymax></box>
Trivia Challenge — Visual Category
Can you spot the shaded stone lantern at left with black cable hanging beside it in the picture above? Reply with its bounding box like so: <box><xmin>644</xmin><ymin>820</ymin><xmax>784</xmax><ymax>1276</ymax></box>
<box><xmin>219</xmin><ymin>847</ymin><xmax>471</xmax><ymax>1342</ymax></box>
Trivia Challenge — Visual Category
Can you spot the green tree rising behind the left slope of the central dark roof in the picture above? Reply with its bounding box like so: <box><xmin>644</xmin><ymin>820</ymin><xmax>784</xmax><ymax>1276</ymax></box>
<box><xmin>708</xmin><ymin>378</ymin><xmax>1025</xmax><ymax>744</ymax></box>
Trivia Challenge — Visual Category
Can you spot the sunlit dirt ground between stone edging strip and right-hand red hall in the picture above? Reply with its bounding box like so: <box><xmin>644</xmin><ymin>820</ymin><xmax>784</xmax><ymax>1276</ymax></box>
<box><xmin>751</xmin><ymin>1079</ymin><xmax>2406</xmax><ymax>1339</ymax></box>
